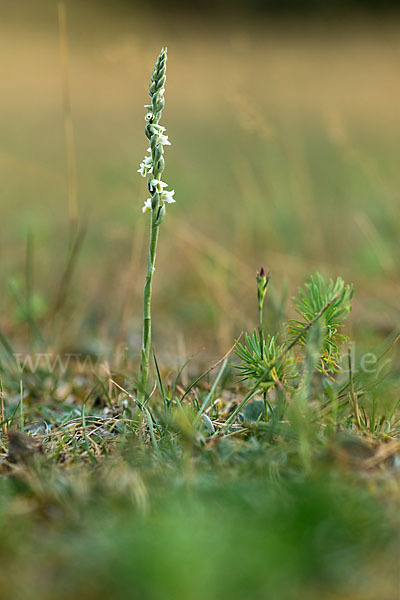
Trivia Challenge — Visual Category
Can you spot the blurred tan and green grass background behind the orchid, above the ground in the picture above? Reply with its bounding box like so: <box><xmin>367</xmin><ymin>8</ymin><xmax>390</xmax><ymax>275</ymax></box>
<box><xmin>0</xmin><ymin>0</ymin><xmax>400</xmax><ymax>360</ymax></box>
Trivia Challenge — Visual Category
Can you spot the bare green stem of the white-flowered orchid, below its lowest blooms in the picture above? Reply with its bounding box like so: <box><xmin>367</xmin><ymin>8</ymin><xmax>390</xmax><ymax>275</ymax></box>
<box><xmin>138</xmin><ymin>210</ymin><xmax>159</xmax><ymax>402</ymax></box>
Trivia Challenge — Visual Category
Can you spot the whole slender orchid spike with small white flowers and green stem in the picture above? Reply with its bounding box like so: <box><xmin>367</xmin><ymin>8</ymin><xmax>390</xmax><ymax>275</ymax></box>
<box><xmin>138</xmin><ymin>48</ymin><xmax>175</xmax><ymax>401</ymax></box>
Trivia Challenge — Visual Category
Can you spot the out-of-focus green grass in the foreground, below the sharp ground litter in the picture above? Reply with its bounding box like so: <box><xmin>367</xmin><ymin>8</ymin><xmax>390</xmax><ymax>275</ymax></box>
<box><xmin>0</xmin><ymin>438</ymin><xmax>398</xmax><ymax>600</ymax></box>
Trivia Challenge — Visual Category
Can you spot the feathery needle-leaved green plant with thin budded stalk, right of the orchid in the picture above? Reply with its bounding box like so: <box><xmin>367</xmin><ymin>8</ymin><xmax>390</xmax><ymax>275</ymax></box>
<box><xmin>235</xmin><ymin>269</ymin><xmax>353</xmax><ymax>414</ymax></box>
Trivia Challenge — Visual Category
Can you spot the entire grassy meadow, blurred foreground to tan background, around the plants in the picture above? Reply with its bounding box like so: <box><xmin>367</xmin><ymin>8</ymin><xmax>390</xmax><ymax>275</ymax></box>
<box><xmin>0</xmin><ymin>2</ymin><xmax>400</xmax><ymax>600</ymax></box>
